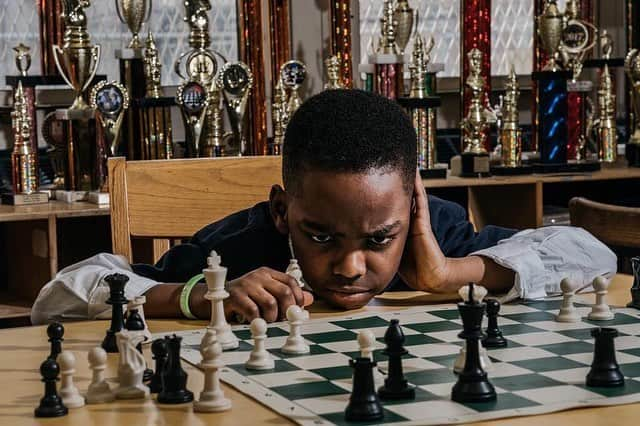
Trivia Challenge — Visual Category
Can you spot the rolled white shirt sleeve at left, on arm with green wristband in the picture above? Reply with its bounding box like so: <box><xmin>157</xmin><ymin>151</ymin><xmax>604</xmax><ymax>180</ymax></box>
<box><xmin>31</xmin><ymin>253</ymin><xmax>158</xmax><ymax>325</ymax></box>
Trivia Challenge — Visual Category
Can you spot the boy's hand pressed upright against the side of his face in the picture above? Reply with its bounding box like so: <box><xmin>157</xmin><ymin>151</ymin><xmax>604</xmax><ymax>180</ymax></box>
<box><xmin>398</xmin><ymin>171</ymin><xmax>454</xmax><ymax>293</ymax></box>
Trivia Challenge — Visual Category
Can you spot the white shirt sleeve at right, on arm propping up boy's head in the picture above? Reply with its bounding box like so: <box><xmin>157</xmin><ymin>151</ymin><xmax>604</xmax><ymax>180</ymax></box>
<box><xmin>472</xmin><ymin>226</ymin><xmax>617</xmax><ymax>302</ymax></box>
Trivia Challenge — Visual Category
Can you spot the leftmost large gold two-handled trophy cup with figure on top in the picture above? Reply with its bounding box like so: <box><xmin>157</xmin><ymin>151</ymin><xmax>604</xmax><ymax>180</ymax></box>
<box><xmin>53</xmin><ymin>0</ymin><xmax>100</xmax><ymax>115</ymax></box>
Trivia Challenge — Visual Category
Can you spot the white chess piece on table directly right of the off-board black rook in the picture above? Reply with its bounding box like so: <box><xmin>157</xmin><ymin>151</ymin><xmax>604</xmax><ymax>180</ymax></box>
<box><xmin>198</xmin><ymin>330</ymin><xmax>231</xmax><ymax>413</ymax></box>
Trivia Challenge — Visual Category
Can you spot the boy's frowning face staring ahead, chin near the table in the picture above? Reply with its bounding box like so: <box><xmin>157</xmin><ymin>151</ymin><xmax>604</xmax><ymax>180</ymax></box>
<box><xmin>279</xmin><ymin>170</ymin><xmax>411</xmax><ymax>309</ymax></box>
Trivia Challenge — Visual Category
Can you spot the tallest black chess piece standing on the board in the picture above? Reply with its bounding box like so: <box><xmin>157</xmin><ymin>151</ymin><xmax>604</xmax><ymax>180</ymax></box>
<box><xmin>451</xmin><ymin>284</ymin><xmax>496</xmax><ymax>403</ymax></box>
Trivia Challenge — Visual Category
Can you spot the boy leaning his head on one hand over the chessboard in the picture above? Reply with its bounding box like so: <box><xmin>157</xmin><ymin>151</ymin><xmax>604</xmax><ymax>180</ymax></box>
<box><xmin>32</xmin><ymin>90</ymin><xmax>616</xmax><ymax>323</ymax></box>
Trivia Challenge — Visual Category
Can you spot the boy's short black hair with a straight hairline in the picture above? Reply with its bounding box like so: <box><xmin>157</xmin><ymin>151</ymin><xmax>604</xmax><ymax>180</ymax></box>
<box><xmin>282</xmin><ymin>89</ymin><xmax>417</xmax><ymax>193</ymax></box>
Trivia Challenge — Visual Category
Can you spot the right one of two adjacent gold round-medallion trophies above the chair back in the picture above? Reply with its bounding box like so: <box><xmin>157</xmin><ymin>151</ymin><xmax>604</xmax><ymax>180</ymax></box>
<box><xmin>217</xmin><ymin>62</ymin><xmax>253</xmax><ymax>156</ymax></box>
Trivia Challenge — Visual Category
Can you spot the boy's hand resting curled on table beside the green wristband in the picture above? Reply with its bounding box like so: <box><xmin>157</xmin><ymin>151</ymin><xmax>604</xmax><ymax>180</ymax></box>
<box><xmin>224</xmin><ymin>267</ymin><xmax>313</xmax><ymax>322</ymax></box>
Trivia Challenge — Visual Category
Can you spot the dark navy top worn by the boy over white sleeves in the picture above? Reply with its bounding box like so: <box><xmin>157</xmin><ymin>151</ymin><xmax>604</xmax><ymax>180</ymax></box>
<box><xmin>133</xmin><ymin>196</ymin><xmax>516</xmax><ymax>290</ymax></box>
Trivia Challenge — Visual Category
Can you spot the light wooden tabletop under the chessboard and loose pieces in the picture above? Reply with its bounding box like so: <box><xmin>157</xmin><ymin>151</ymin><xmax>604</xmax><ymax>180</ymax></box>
<box><xmin>0</xmin><ymin>275</ymin><xmax>640</xmax><ymax>426</ymax></box>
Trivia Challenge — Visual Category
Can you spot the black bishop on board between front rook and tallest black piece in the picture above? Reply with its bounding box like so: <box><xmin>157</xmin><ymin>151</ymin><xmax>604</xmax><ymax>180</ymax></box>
<box><xmin>378</xmin><ymin>319</ymin><xmax>416</xmax><ymax>400</ymax></box>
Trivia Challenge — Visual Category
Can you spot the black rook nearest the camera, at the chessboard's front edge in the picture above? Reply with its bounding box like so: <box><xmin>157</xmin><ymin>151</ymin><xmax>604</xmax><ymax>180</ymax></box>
<box><xmin>344</xmin><ymin>358</ymin><xmax>384</xmax><ymax>422</ymax></box>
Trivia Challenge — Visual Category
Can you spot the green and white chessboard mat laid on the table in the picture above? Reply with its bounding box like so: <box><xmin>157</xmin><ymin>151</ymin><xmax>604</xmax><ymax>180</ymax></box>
<box><xmin>175</xmin><ymin>299</ymin><xmax>640</xmax><ymax>425</ymax></box>
